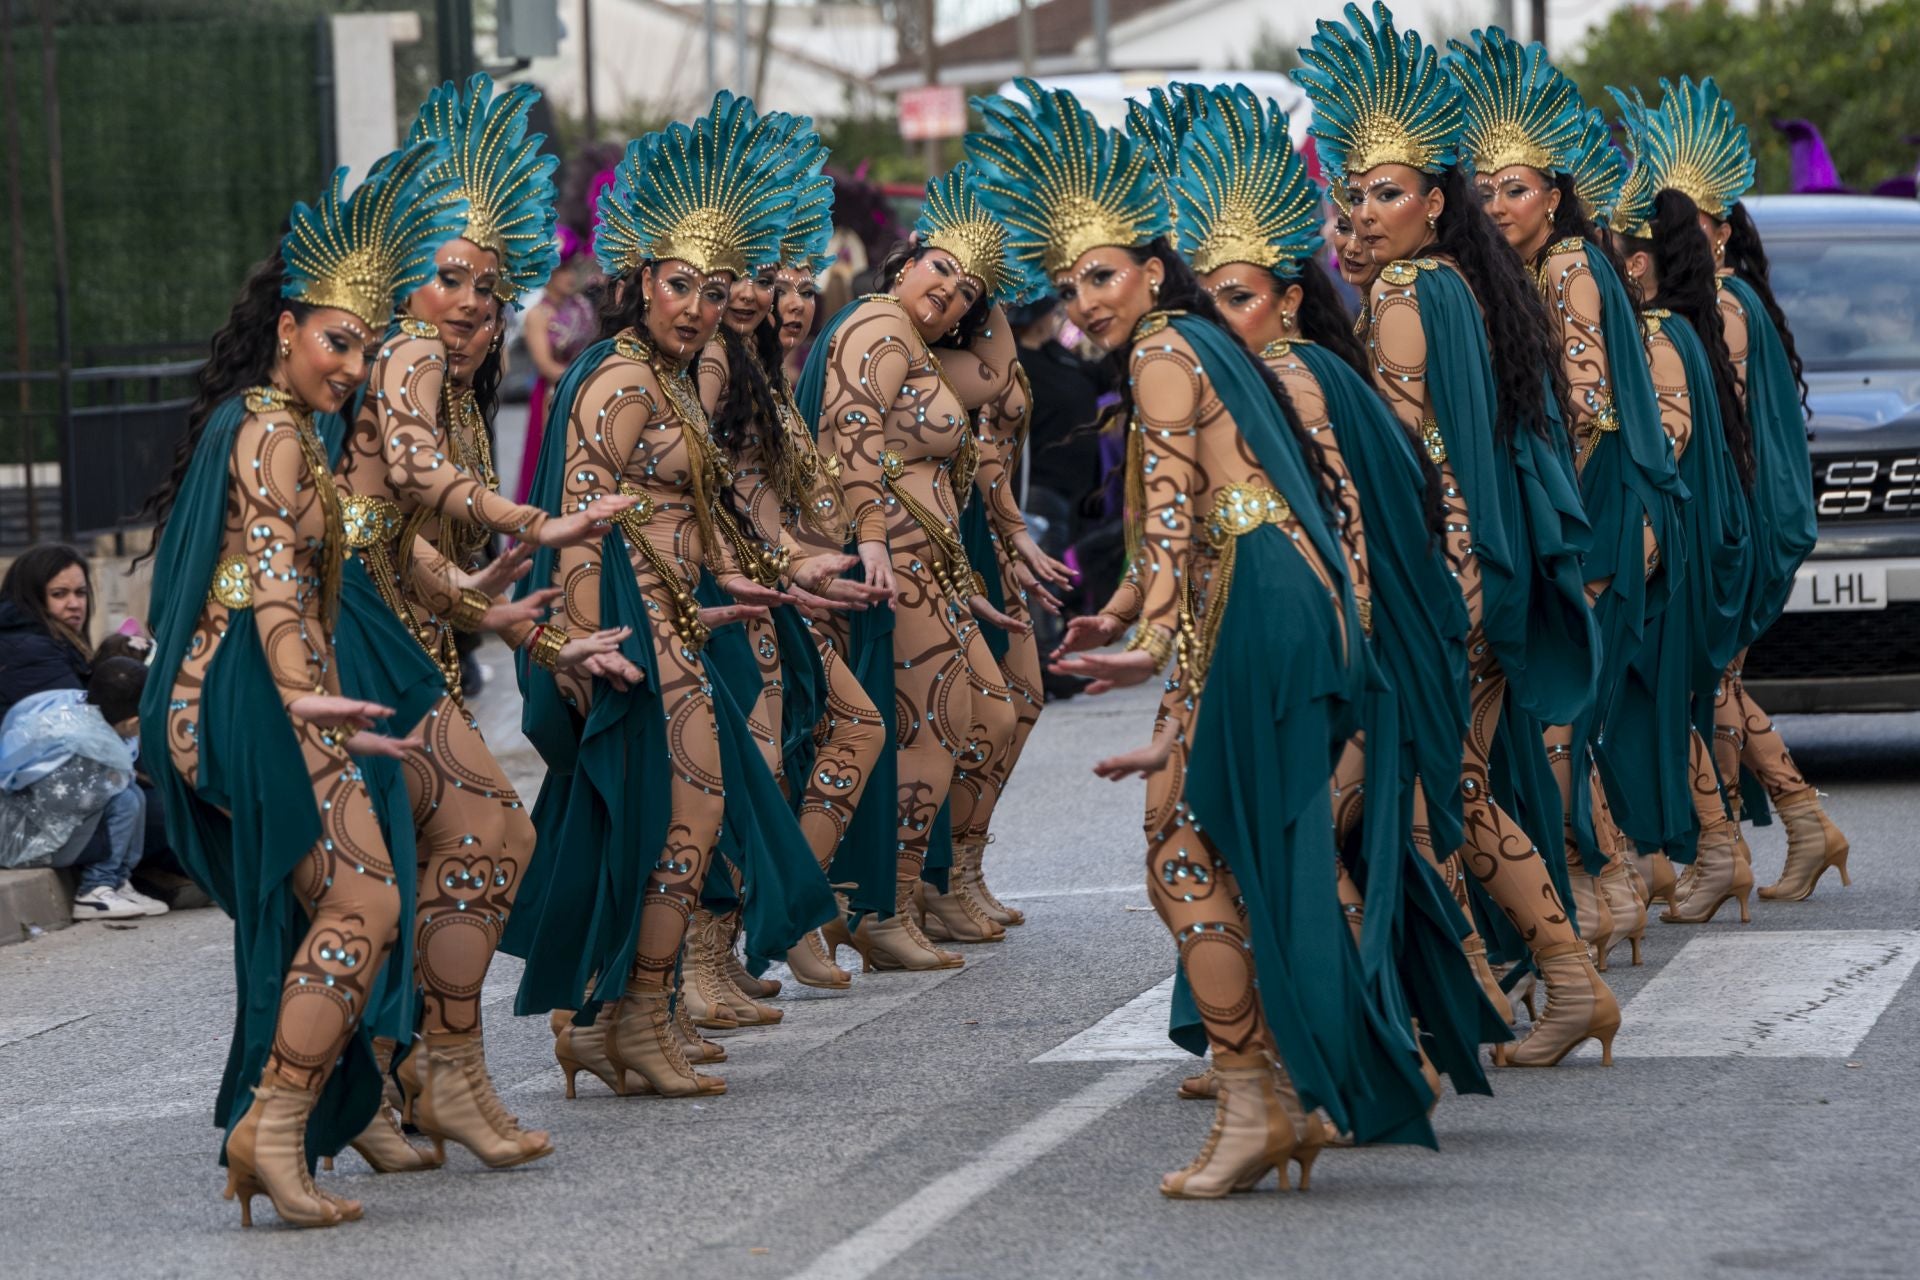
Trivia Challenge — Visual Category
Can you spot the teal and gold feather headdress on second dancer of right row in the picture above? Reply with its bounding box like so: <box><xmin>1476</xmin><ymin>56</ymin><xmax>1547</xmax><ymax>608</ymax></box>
<box><xmin>1173</xmin><ymin>86</ymin><xmax>1321</xmax><ymax>278</ymax></box>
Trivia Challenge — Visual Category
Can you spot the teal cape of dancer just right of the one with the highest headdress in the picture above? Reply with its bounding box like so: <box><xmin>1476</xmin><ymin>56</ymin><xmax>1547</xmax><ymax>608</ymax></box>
<box><xmin>1572</xmin><ymin>244</ymin><xmax>1688</xmax><ymax>875</ymax></box>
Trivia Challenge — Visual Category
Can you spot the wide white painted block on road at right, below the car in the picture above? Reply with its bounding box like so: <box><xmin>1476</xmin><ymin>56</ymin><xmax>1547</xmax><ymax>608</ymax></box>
<box><xmin>1582</xmin><ymin>929</ymin><xmax>1920</xmax><ymax>1057</ymax></box>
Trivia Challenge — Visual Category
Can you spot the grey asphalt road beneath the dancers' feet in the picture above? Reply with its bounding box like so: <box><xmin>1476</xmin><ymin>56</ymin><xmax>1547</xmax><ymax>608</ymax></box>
<box><xmin>0</xmin><ymin>660</ymin><xmax>1920</xmax><ymax>1280</ymax></box>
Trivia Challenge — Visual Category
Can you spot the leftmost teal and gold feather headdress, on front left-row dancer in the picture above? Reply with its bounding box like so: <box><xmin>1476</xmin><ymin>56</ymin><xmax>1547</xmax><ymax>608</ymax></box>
<box><xmin>280</xmin><ymin>142</ymin><xmax>467</xmax><ymax>334</ymax></box>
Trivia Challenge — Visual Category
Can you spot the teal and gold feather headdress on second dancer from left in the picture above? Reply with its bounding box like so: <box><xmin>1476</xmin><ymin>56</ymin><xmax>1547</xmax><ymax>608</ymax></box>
<box><xmin>407</xmin><ymin>73</ymin><xmax>561</xmax><ymax>301</ymax></box>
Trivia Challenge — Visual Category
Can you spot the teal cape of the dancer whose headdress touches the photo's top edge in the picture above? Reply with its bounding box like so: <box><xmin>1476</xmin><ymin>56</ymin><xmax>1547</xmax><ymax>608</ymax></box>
<box><xmin>1415</xmin><ymin>259</ymin><xmax>1599</xmax><ymax>960</ymax></box>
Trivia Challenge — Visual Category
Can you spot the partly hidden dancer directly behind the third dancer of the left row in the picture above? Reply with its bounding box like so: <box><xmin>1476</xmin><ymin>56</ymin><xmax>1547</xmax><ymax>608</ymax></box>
<box><xmin>685</xmin><ymin>113</ymin><xmax>883</xmax><ymax>1029</ymax></box>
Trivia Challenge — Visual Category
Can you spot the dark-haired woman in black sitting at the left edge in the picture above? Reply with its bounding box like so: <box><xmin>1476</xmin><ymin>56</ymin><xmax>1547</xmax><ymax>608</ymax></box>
<box><xmin>0</xmin><ymin>543</ymin><xmax>94</xmax><ymax>718</ymax></box>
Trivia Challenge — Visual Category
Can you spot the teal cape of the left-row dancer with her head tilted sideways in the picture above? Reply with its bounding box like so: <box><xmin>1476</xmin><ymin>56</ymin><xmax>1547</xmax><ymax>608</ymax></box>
<box><xmin>793</xmin><ymin>297</ymin><xmax>910</xmax><ymax>917</ymax></box>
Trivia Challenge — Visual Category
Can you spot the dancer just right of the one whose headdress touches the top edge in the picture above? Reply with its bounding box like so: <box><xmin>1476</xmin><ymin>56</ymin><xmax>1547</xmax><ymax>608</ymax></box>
<box><xmin>1446</xmin><ymin>27</ymin><xmax>1690</xmax><ymax>971</ymax></box>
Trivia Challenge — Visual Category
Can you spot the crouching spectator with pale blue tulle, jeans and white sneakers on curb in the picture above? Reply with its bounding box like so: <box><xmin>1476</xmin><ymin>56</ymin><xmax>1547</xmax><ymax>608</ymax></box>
<box><xmin>0</xmin><ymin>658</ymin><xmax>167</xmax><ymax>919</ymax></box>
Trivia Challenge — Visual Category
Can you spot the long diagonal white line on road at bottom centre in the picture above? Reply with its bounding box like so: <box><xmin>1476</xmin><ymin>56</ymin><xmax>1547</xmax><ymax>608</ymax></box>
<box><xmin>789</xmin><ymin>1065</ymin><xmax>1165</xmax><ymax>1280</ymax></box>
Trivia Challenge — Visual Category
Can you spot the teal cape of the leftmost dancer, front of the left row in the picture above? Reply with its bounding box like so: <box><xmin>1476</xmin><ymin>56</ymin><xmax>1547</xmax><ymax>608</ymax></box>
<box><xmin>140</xmin><ymin>395</ymin><xmax>415</xmax><ymax>1161</ymax></box>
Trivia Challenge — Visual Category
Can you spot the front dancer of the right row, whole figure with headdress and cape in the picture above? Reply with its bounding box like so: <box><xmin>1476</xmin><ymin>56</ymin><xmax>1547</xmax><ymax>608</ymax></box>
<box><xmin>966</xmin><ymin>81</ymin><xmax>1432</xmax><ymax>1197</ymax></box>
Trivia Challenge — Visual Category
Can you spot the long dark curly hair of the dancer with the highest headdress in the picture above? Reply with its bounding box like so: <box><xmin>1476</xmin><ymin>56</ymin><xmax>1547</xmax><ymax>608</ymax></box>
<box><xmin>1421</xmin><ymin>167</ymin><xmax>1571</xmax><ymax>445</ymax></box>
